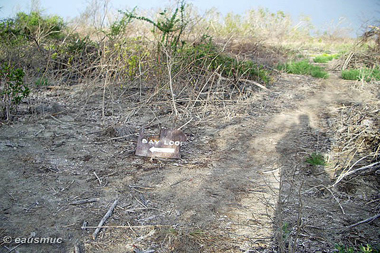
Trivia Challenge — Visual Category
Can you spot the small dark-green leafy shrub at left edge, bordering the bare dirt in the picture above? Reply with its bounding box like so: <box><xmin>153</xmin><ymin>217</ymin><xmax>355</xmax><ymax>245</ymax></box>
<box><xmin>0</xmin><ymin>64</ymin><xmax>30</xmax><ymax>120</ymax></box>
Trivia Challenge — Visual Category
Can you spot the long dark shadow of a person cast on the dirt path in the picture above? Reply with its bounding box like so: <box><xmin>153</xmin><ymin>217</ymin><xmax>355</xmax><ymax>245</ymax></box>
<box><xmin>276</xmin><ymin>114</ymin><xmax>339</xmax><ymax>252</ymax></box>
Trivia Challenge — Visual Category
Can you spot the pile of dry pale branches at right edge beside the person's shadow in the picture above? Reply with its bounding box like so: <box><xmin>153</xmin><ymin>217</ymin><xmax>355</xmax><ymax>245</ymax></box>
<box><xmin>334</xmin><ymin>103</ymin><xmax>380</xmax><ymax>188</ymax></box>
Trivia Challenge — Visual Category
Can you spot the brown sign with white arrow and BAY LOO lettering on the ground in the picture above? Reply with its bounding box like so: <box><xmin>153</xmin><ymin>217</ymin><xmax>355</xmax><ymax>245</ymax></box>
<box><xmin>135</xmin><ymin>128</ymin><xmax>187</xmax><ymax>158</ymax></box>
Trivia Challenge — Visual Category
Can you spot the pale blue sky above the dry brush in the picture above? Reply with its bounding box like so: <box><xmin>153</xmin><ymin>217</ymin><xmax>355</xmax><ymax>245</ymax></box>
<box><xmin>0</xmin><ymin>0</ymin><xmax>380</xmax><ymax>37</ymax></box>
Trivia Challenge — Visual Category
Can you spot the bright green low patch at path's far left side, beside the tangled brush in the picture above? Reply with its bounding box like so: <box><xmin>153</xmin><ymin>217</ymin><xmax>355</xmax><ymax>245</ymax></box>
<box><xmin>277</xmin><ymin>60</ymin><xmax>329</xmax><ymax>78</ymax></box>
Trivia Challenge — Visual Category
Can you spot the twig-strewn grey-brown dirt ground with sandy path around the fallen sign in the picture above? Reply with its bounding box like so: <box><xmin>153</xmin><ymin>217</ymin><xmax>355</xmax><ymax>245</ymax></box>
<box><xmin>0</xmin><ymin>67</ymin><xmax>380</xmax><ymax>253</ymax></box>
